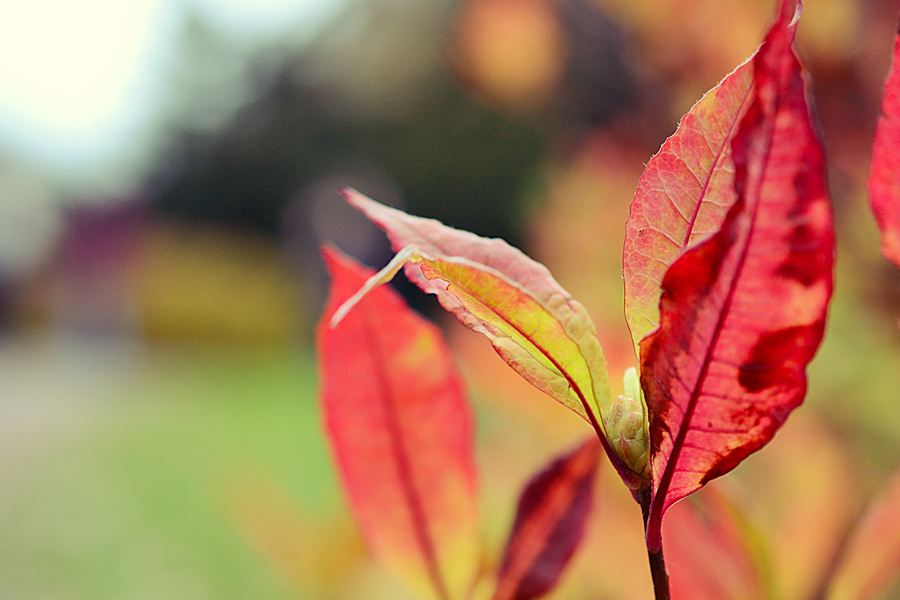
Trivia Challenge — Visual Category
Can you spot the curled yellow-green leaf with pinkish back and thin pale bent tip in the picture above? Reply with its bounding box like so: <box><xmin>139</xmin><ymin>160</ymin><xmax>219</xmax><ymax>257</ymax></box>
<box><xmin>338</xmin><ymin>190</ymin><xmax>646</xmax><ymax>489</ymax></box>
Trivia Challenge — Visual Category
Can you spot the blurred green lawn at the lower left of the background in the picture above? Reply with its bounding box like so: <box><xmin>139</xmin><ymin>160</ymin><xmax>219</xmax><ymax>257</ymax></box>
<box><xmin>0</xmin><ymin>340</ymin><xmax>341</xmax><ymax>600</ymax></box>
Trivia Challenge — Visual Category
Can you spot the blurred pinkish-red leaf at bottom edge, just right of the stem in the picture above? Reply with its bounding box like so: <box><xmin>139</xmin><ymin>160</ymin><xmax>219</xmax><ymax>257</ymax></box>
<box><xmin>663</xmin><ymin>486</ymin><xmax>771</xmax><ymax>600</ymax></box>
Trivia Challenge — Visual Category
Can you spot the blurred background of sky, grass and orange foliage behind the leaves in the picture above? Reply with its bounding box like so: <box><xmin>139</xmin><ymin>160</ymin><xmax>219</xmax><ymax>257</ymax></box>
<box><xmin>0</xmin><ymin>0</ymin><xmax>900</xmax><ymax>600</ymax></box>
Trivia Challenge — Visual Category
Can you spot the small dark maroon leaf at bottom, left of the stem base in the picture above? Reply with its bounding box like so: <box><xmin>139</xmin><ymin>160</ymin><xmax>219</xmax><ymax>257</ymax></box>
<box><xmin>493</xmin><ymin>437</ymin><xmax>600</xmax><ymax>600</ymax></box>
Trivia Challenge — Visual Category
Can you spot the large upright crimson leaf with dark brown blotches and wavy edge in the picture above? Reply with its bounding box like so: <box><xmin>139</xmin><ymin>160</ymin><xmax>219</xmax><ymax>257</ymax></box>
<box><xmin>641</xmin><ymin>0</ymin><xmax>834</xmax><ymax>553</ymax></box>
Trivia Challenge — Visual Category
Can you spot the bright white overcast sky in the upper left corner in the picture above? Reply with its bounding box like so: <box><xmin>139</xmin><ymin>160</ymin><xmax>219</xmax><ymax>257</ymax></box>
<box><xmin>0</xmin><ymin>0</ymin><xmax>340</xmax><ymax>170</ymax></box>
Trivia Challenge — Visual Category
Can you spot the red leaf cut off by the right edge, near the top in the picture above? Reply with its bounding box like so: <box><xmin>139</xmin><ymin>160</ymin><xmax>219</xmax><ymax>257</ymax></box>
<box><xmin>868</xmin><ymin>11</ymin><xmax>900</xmax><ymax>267</ymax></box>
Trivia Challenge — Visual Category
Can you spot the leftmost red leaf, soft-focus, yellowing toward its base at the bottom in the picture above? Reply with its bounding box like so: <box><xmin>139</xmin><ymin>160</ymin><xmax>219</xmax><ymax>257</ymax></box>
<box><xmin>317</xmin><ymin>248</ymin><xmax>478</xmax><ymax>600</ymax></box>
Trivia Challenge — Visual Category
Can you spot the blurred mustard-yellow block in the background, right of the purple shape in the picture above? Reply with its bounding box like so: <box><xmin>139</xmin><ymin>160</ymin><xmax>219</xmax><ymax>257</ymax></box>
<box><xmin>137</xmin><ymin>225</ymin><xmax>302</xmax><ymax>343</ymax></box>
